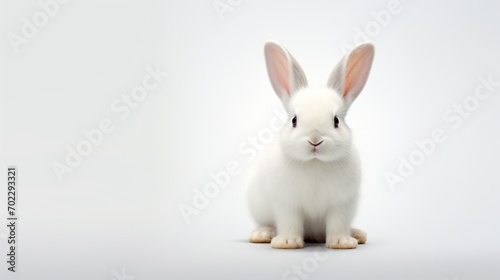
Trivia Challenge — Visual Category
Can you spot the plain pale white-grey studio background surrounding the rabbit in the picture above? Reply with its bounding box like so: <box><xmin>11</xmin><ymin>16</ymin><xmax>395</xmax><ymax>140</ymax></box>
<box><xmin>0</xmin><ymin>0</ymin><xmax>500</xmax><ymax>280</ymax></box>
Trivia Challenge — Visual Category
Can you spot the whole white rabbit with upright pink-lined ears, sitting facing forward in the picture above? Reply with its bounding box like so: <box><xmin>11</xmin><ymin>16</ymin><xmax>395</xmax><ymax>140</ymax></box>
<box><xmin>248</xmin><ymin>42</ymin><xmax>374</xmax><ymax>249</ymax></box>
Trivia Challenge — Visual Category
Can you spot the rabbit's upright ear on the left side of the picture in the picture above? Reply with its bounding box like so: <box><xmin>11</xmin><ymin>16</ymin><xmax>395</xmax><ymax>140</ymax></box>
<box><xmin>264</xmin><ymin>42</ymin><xmax>307</xmax><ymax>109</ymax></box>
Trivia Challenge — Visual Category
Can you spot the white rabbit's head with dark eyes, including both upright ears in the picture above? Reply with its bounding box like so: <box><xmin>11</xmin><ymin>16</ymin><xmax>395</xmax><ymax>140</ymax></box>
<box><xmin>264</xmin><ymin>42</ymin><xmax>374</xmax><ymax>162</ymax></box>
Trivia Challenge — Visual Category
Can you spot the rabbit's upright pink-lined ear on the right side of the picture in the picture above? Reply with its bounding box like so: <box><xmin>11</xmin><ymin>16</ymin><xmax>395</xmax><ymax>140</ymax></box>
<box><xmin>328</xmin><ymin>43</ymin><xmax>375</xmax><ymax>108</ymax></box>
